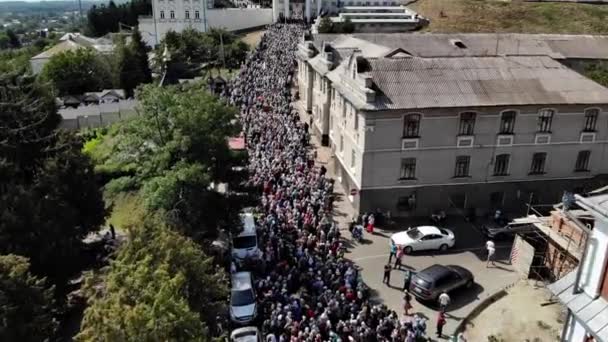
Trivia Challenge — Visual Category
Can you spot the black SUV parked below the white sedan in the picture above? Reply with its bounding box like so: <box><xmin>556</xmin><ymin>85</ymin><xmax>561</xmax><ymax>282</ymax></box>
<box><xmin>410</xmin><ymin>264</ymin><xmax>475</xmax><ymax>301</ymax></box>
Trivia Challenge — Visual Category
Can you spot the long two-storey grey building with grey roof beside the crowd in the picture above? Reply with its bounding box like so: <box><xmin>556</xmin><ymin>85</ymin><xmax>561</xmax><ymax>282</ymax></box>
<box><xmin>298</xmin><ymin>34</ymin><xmax>608</xmax><ymax>216</ymax></box>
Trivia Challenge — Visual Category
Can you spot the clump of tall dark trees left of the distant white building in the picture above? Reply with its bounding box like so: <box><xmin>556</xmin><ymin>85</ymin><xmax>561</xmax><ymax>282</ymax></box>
<box><xmin>87</xmin><ymin>0</ymin><xmax>152</xmax><ymax>37</ymax></box>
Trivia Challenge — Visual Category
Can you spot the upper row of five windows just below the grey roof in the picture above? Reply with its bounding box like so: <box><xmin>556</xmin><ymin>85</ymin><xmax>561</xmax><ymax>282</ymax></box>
<box><xmin>403</xmin><ymin>108</ymin><xmax>600</xmax><ymax>138</ymax></box>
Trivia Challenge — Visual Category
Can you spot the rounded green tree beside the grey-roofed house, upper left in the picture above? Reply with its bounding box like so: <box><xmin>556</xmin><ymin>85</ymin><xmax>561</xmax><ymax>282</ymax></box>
<box><xmin>40</xmin><ymin>49</ymin><xmax>112</xmax><ymax>96</ymax></box>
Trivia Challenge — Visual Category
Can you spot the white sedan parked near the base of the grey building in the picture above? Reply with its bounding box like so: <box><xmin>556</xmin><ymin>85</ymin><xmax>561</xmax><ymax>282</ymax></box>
<box><xmin>390</xmin><ymin>226</ymin><xmax>456</xmax><ymax>254</ymax></box>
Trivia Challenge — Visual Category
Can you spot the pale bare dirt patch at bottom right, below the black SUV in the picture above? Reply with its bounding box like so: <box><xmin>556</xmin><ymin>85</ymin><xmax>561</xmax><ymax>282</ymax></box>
<box><xmin>465</xmin><ymin>281</ymin><xmax>565</xmax><ymax>342</ymax></box>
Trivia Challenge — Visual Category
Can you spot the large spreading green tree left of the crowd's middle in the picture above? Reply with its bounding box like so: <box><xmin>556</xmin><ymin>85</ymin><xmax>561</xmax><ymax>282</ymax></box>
<box><xmin>91</xmin><ymin>85</ymin><xmax>238</xmax><ymax>240</ymax></box>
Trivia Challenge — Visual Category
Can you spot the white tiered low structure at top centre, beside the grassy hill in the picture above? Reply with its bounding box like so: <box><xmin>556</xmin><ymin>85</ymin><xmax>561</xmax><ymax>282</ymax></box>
<box><xmin>311</xmin><ymin>2</ymin><xmax>428</xmax><ymax>34</ymax></box>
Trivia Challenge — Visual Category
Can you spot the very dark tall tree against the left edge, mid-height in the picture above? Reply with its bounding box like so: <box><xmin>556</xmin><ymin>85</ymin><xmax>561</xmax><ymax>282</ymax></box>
<box><xmin>0</xmin><ymin>75</ymin><xmax>105</xmax><ymax>284</ymax></box>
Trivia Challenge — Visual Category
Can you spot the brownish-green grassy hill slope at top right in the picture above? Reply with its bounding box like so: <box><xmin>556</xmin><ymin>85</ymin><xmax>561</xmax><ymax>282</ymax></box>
<box><xmin>409</xmin><ymin>0</ymin><xmax>608</xmax><ymax>34</ymax></box>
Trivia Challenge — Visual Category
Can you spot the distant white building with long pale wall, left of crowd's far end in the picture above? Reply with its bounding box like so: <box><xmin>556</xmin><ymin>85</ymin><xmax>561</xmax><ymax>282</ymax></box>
<box><xmin>138</xmin><ymin>0</ymin><xmax>273</xmax><ymax>46</ymax></box>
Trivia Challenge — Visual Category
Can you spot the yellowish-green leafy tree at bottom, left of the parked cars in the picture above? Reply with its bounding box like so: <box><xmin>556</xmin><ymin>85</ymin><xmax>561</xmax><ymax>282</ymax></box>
<box><xmin>76</xmin><ymin>219</ymin><xmax>227</xmax><ymax>341</ymax></box>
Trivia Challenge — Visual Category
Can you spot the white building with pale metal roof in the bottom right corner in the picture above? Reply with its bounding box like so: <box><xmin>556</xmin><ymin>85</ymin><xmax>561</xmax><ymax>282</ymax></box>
<box><xmin>549</xmin><ymin>193</ymin><xmax>608</xmax><ymax>342</ymax></box>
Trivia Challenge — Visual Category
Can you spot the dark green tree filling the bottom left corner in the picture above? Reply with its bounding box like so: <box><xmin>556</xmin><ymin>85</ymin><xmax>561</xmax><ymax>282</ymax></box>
<box><xmin>0</xmin><ymin>254</ymin><xmax>57</xmax><ymax>341</ymax></box>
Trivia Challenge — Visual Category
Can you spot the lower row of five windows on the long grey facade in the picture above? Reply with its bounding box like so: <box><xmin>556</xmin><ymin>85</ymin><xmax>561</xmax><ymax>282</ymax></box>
<box><xmin>400</xmin><ymin>151</ymin><xmax>591</xmax><ymax>179</ymax></box>
